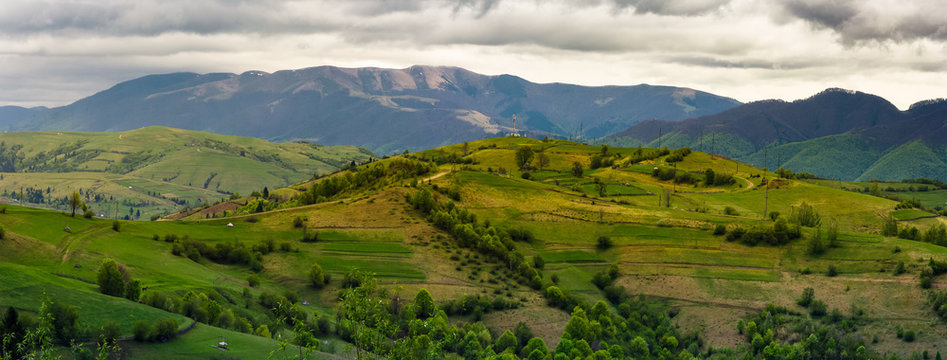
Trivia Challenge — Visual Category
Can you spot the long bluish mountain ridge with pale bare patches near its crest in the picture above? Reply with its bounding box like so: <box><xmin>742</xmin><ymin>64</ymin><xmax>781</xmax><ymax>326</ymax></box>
<box><xmin>14</xmin><ymin>66</ymin><xmax>740</xmax><ymax>154</ymax></box>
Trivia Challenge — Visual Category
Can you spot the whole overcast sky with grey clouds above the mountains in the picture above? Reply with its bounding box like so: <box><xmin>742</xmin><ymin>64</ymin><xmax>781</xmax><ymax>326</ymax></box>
<box><xmin>0</xmin><ymin>0</ymin><xmax>947</xmax><ymax>109</ymax></box>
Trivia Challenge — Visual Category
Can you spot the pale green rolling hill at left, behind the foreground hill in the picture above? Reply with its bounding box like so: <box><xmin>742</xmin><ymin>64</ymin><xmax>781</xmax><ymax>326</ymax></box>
<box><xmin>0</xmin><ymin>127</ymin><xmax>372</xmax><ymax>219</ymax></box>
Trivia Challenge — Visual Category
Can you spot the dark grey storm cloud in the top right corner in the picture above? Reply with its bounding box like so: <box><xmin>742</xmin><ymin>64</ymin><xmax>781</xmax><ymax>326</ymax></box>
<box><xmin>782</xmin><ymin>0</ymin><xmax>947</xmax><ymax>44</ymax></box>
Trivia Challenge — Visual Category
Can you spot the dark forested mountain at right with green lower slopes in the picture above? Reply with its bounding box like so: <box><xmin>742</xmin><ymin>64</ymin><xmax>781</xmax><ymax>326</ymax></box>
<box><xmin>598</xmin><ymin>89</ymin><xmax>947</xmax><ymax>181</ymax></box>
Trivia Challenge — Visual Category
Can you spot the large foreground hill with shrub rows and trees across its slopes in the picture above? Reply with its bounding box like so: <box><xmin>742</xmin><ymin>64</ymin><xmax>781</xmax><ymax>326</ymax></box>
<box><xmin>0</xmin><ymin>137</ymin><xmax>947</xmax><ymax>359</ymax></box>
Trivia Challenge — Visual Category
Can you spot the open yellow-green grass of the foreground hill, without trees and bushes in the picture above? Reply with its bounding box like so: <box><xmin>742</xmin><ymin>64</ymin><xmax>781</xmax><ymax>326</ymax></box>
<box><xmin>0</xmin><ymin>135</ymin><xmax>947</xmax><ymax>359</ymax></box>
